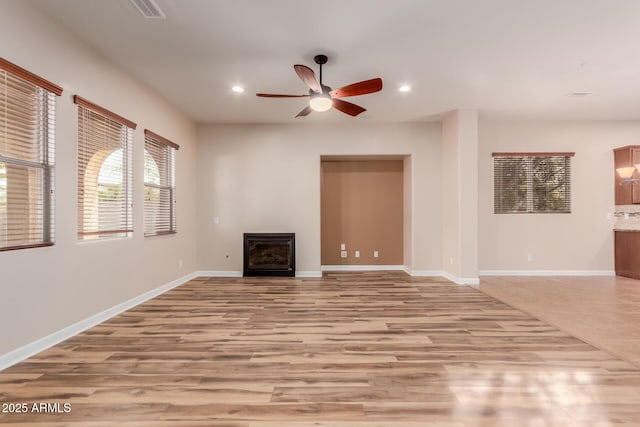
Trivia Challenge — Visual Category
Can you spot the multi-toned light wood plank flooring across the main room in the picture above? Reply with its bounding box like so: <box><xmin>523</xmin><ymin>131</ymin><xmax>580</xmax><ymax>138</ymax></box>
<box><xmin>0</xmin><ymin>272</ymin><xmax>640</xmax><ymax>427</ymax></box>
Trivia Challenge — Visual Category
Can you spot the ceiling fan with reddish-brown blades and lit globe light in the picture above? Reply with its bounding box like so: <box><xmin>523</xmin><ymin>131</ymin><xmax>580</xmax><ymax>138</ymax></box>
<box><xmin>256</xmin><ymin>55</ymin><xmax>382</xmax><ymax>117</ymax></box>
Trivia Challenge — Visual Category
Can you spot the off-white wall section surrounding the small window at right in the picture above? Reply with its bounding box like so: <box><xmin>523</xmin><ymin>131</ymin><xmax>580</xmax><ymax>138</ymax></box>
<box><xmin>479</xmin><ymin>120</ymin><xmax>640</xmax><ymax>274</ymax></box>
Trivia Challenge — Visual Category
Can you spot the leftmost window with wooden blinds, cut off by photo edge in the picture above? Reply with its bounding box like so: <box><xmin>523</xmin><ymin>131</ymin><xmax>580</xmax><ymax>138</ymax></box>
<box><xmin>0</xmin><ymin>58</ymin><xmax>62</xmax><ymax>250</ymax></box>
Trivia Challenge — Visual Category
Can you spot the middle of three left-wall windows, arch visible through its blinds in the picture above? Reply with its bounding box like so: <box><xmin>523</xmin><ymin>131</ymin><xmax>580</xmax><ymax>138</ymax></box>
<box><xmin>74</xmin><ymin>95</ymin><xmax>136</xmax><ymax>240</ymax></box>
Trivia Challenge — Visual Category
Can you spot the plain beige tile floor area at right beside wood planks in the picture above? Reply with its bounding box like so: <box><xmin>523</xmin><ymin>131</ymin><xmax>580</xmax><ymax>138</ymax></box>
<box><xmin>479</xmin><ymin>277</ymin><xmax>640</xmax><ymax>370</ymax></box>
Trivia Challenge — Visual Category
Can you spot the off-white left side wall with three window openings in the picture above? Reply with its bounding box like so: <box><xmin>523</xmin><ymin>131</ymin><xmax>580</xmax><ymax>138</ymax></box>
<box><xmin>0</xmin><ymin>0</ymin><xmax>196</xmax><ymax>357</ymax></box>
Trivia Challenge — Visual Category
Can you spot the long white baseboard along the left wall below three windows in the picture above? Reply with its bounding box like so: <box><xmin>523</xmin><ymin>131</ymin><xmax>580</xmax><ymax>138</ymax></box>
<box><xmin>0</xmin><ymin>272</ymin><xmax>197</xmax><ymax>371</ymax></box>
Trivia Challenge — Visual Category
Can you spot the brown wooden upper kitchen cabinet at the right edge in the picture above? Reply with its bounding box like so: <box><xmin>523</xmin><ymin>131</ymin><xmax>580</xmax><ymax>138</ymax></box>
<box><xmin>613</xmin><ymin>145</ymin><xmax>640</xmax><ymax>205</ymax></box>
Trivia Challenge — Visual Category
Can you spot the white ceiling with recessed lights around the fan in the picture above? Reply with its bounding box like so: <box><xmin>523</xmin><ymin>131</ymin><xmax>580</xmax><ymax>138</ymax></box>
<box><xmin>29</xmin><ymin>0</ymin><xmax>640</xmax><ymax>123</ymax></box>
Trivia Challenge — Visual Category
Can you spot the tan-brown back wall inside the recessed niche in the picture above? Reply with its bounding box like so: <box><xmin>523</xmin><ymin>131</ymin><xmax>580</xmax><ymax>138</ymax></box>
<box><xmin>321</xmin><ymin>160</ymin><xmax>404</xmax><ymax>265</ymax></box>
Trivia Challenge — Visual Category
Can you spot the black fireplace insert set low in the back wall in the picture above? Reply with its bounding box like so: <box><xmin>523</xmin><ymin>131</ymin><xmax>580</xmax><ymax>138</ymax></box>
<box><xmin>243</xmin><ymin>233</ymin><xmax>296</xmax><ymax>276</ymax></box>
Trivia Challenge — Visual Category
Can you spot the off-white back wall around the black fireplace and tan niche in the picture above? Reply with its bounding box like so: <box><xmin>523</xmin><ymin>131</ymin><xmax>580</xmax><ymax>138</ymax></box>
<box><xmin>197</xmin><ymin>122</ymin><xmax>441</xmax><ymax>274</ymax></box>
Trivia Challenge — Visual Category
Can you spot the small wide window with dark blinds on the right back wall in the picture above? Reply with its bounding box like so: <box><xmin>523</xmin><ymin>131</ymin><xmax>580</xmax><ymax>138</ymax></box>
<box><xmin>493</xmin><ymin>153</ymin><xmax>574</xmax><ymax>214</ymax></box>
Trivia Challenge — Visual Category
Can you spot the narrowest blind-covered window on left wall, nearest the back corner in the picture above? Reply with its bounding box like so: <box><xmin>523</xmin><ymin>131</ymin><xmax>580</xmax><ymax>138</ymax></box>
<box><xmin>144</xmin><ymin>129</ymin><xmax>180</xmax><ymax>236</ymax></box>
